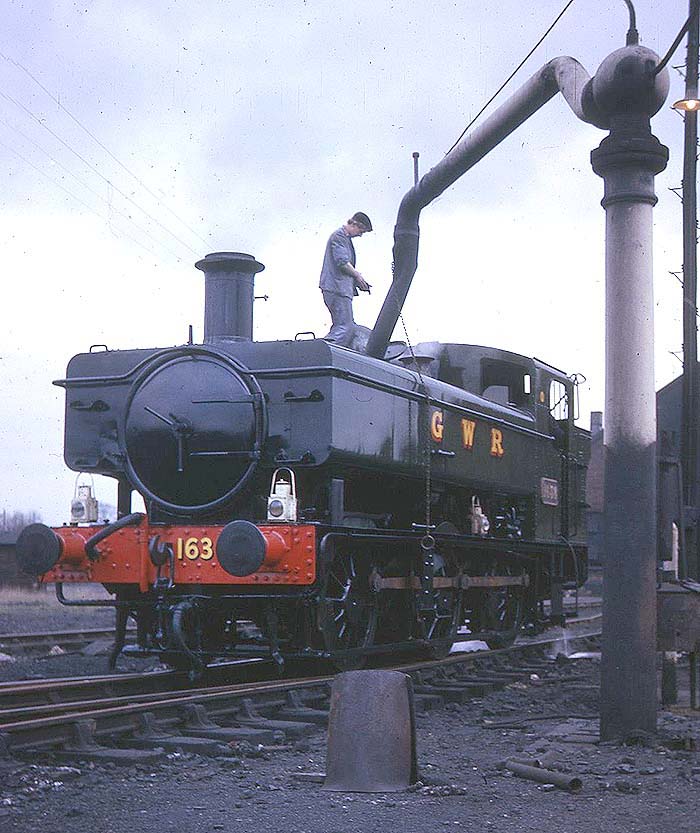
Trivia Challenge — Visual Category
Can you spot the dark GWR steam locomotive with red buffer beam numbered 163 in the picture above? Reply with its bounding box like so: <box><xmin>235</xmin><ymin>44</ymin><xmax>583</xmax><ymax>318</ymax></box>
<box><xmin>18</xmin><ymin>245</ymin><xmax>589</xmax><ymax>670</ymax></box>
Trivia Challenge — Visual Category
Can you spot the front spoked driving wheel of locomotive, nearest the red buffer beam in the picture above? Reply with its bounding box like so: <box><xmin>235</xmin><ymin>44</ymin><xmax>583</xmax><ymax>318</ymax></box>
<box><xmin>315</xmin><ymin>552</ymin><xmax>377</xmax><ymax>671</ymax></box>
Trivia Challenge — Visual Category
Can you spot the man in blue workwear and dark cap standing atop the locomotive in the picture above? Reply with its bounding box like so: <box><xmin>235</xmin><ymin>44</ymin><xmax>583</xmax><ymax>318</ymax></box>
<box><xmin>319</xmin><ymin>211</ymin><xmax>372</xmax><ymax>347</ymax></box>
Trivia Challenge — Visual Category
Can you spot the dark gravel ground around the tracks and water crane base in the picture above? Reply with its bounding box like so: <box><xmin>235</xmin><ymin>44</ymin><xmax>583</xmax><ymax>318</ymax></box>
<box><xmin>0</xmin><ymin>572</ymin><xmax>700</xmax><ymax>833</ymax></box>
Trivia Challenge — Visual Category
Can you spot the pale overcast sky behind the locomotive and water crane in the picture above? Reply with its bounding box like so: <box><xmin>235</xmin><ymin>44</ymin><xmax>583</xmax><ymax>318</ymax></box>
<box><xmin>0</xmin><ymin>0</ymin><xmax>687</xmax><ymax>523</ymax></box>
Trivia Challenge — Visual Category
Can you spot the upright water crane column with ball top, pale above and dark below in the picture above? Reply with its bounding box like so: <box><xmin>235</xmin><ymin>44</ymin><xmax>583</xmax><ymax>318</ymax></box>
<box><xmin>591</xmin><ymin>46</ymin><xmax>668</xmax><ymax>740</ymax></box>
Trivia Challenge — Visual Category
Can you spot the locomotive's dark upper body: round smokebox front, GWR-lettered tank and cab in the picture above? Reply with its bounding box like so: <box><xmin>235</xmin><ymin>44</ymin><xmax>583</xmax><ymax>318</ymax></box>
<box><xmin>58</xmin><ymin>339</ymin><xmax>587</xmax><ymax>539</ymax></box>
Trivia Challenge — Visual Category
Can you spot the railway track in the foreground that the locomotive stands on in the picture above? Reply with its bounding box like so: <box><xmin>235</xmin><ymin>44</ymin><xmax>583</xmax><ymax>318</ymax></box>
<box><xmin>0</xmin><ymin>618</ymin><xmax>599</xmax><ymax>763</ymax></box>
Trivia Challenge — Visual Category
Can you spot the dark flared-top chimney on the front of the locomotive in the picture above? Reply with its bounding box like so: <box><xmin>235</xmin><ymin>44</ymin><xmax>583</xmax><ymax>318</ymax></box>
<box><xmin>195</xmin><ymin>252</ymin><xmax>265</xmax><ymax>344</ymax></box>
